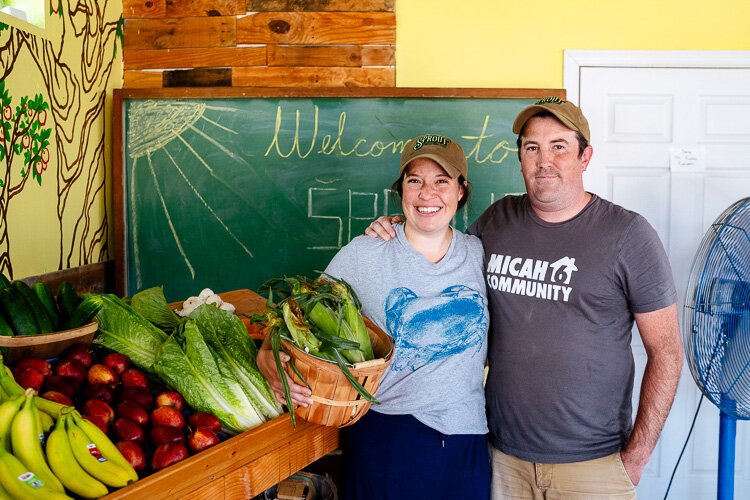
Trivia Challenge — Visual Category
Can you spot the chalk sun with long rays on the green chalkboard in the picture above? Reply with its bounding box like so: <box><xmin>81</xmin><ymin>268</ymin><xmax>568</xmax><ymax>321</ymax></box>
<box><xmin>128</xmin><ymin>100</ymin><xmax>253</xmax><ymax>288</ymax></box>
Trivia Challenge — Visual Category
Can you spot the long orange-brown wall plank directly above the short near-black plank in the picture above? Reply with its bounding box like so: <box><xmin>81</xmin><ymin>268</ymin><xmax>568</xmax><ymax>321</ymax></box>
<box><xmin>123</xmin><ymin>46</ymin><xmax>266</xmax><ymax>69</ymax></box>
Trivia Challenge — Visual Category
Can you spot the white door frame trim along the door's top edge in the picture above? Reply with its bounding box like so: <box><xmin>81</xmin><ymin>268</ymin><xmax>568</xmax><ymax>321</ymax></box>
<box><xmin>563</xmin><ymin>50</ymin><xmax>750</xmax><ymax>104</ymax></box>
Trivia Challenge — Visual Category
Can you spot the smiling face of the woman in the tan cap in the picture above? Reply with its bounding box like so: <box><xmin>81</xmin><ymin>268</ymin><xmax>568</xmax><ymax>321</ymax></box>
<box><xmin>401</xmin><ymin>158</ymin><xmax>464</xmax><ymax>234</ymax></box>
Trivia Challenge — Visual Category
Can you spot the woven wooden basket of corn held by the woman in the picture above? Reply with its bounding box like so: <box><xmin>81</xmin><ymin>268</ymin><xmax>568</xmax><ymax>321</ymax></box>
<box><xmin>282</xmin><ymin>318</ymin><xmax>394</xmax><ymax>427</ymax></box>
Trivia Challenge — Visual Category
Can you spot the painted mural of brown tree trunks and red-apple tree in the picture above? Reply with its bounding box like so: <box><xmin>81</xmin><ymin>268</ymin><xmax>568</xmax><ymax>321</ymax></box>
<box><xmin>0</xmin><ymin>0</ymin><xmax>122</xmax><ymax>277</ymax></box>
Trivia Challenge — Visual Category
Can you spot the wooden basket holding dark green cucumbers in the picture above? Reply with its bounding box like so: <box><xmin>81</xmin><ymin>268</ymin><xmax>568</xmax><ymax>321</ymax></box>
<box><xmin>0</xmin><ymin>321</ymin><xmax>99</xmax><ymax>363</ymax></box>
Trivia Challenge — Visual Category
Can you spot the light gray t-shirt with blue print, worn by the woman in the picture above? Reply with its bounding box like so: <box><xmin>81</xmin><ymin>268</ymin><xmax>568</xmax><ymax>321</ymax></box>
<box><xmin>326</xmin><ymin>225</ymin><xmax>489</xmax><ymax>434</ymax></box>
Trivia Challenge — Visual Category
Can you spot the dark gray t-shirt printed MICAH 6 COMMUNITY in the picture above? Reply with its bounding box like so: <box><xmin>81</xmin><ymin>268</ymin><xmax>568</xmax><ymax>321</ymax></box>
<box><xmin>469</xmin><ymin>195</ymin><xmax>675</xmax><ymax>463</ymax></box>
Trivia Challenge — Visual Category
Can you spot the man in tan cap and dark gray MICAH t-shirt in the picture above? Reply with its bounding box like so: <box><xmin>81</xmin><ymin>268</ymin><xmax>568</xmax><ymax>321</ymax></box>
<box><xmin>368</xmin><ymin>98</ymin><xmax>682</xmax><ymax>499</ymax></box>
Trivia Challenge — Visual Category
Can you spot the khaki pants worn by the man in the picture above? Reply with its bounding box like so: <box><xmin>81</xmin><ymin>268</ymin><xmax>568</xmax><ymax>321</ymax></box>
<box><xmin>490</xmin><ymin>447</ymin><xmax>636</xmax><ymax>500</ymax></box>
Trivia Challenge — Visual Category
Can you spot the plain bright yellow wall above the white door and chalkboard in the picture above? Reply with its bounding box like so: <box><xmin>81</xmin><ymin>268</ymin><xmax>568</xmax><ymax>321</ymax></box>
<box><xmin>396</xmin><ymin>0</ymin><xmax>750</xmax><ymax>88</ymax></box>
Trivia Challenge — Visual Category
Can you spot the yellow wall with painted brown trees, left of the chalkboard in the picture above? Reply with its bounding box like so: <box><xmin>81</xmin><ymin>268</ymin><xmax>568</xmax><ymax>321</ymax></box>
<box><xmin>0</xmin><ymin>0</ymin><xmax>122</xmax><ymax>279</ymax></box>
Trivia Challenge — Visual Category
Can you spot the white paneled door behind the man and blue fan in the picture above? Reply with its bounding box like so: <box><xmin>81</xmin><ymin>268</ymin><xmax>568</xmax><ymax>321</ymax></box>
<box><xmin>566</xmin><ymin>52</ymin><xmax>750</xmax><ymax>499</ymax></box>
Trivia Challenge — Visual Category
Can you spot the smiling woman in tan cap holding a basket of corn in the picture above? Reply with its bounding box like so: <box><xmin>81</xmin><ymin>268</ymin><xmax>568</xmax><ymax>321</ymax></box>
<box><xmin>258</xmin><ymin>135</ymin><xmax>490</xmax><ymax>500</ymax></box>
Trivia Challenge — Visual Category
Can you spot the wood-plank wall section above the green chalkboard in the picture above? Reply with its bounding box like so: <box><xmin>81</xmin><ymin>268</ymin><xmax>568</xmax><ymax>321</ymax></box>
<box><xmin>123</xmin><ymin>0</ymin><xmax>396</xmax><ymax>88</ymax></box>
